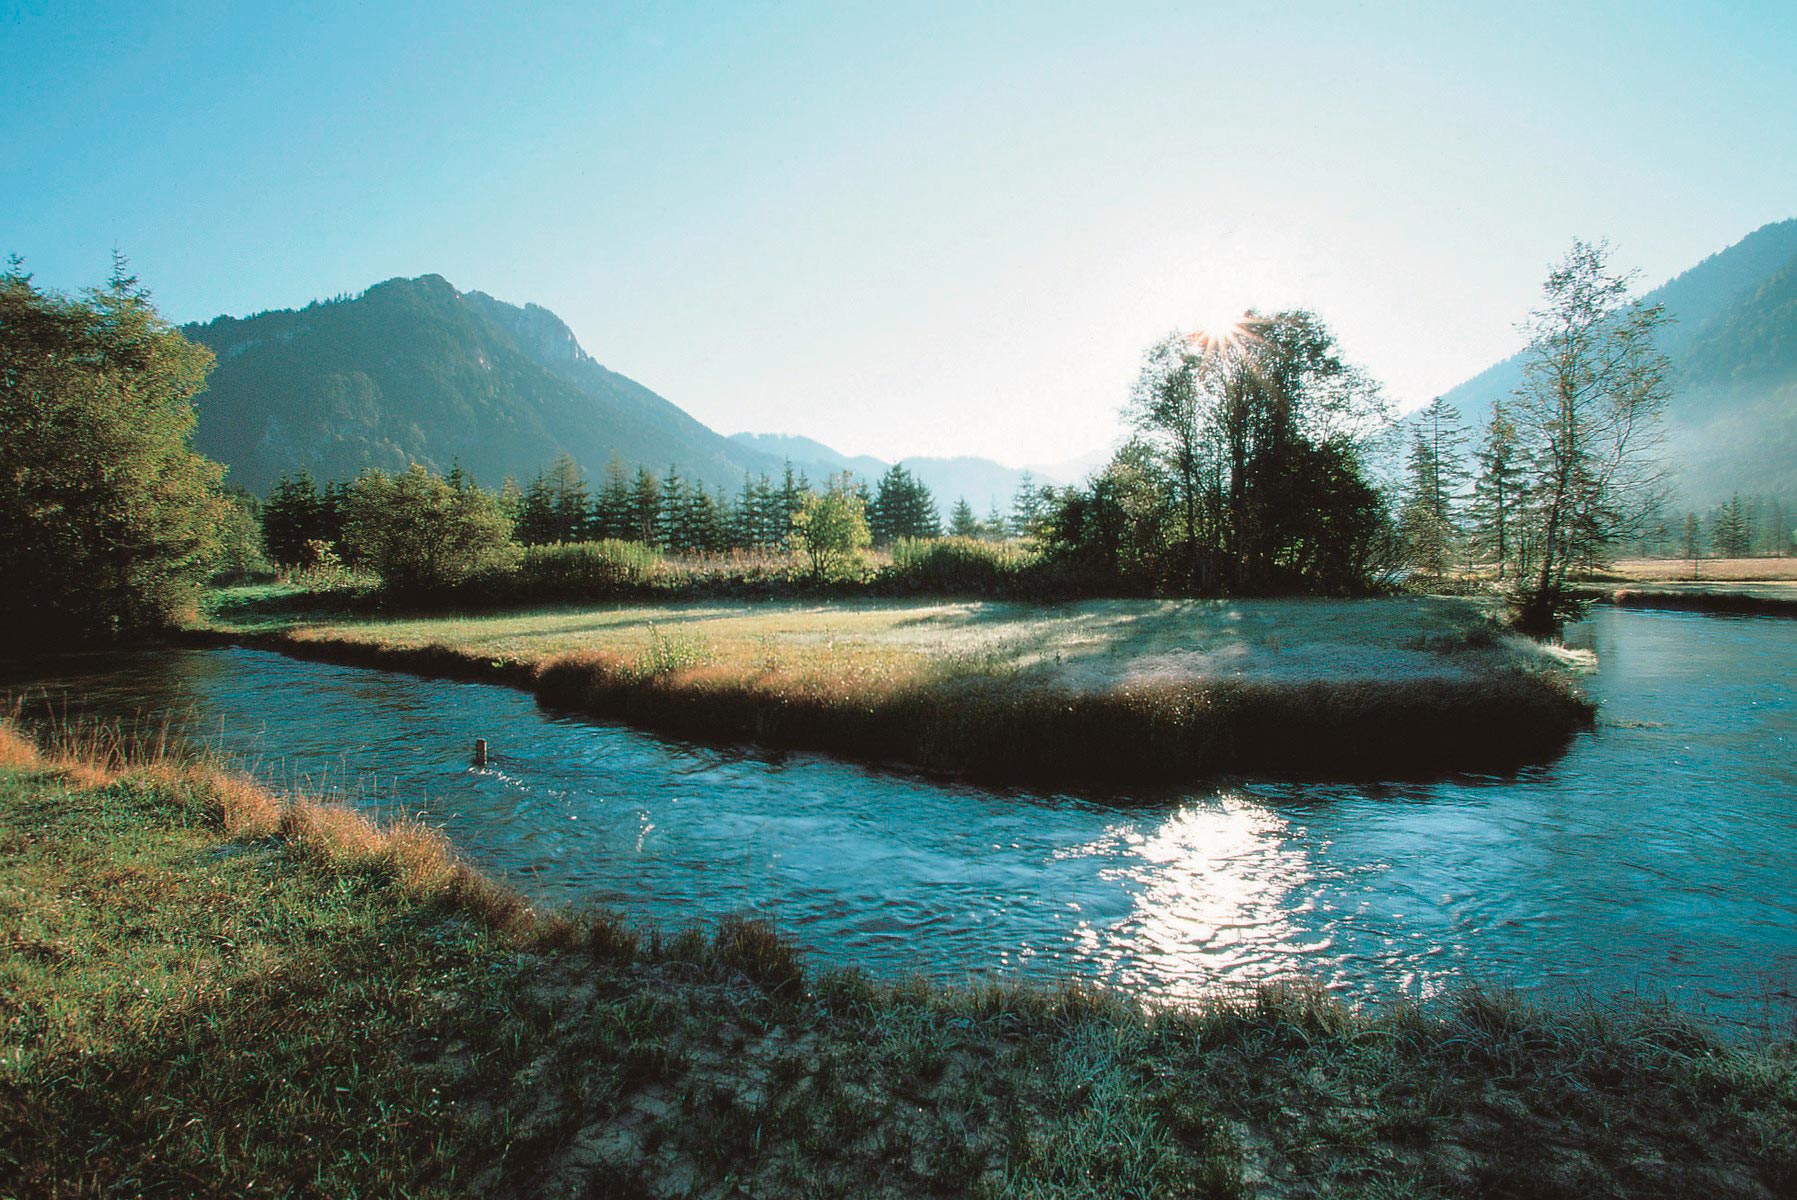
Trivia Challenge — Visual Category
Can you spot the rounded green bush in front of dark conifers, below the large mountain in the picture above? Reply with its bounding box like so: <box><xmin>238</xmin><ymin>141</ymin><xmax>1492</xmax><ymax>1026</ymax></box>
<box><xmin>343</xmin><ymin>463</ymin><xmax>516</xmax><ymax>596</ymax></box>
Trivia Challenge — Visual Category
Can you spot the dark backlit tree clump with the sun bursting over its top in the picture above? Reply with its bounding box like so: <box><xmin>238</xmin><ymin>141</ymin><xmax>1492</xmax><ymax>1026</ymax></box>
<box><xmin>1044</xmin><ymin>313</ymin><xmax>1387</xmax><ymax>595</ymax></box>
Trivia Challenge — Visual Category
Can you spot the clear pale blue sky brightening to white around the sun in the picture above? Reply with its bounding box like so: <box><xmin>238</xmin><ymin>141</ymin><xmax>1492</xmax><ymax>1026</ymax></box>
<box><xmin>0</xmin><ymin>0</ymin><xmax>1797</xmax><ymax>465</ymax></box>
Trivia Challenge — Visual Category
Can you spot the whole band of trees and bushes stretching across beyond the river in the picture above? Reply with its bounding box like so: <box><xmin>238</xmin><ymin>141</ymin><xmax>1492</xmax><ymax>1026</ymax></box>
<box><xmin>0</xmin><ymin>243</ymin><xmax>1739</xmax><ymax>634</ymax></box>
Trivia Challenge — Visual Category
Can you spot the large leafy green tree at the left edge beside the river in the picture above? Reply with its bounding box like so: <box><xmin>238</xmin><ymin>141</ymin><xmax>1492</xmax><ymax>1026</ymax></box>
<box><xmin>0</xmin><ymin>257</ymin><xmax>226</xmax><ymax>647</ymax></box>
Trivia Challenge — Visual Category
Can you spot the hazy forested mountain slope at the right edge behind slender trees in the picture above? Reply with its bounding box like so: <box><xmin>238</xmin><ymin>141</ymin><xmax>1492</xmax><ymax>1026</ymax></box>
<box><xmin>1423</xmin><ymin>219</ymin><xmax>1797</xmax><ymax>508</ymax></box>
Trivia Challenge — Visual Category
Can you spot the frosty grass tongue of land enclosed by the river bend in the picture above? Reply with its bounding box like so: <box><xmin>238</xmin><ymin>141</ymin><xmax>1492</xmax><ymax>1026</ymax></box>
<box><xmin>194</xmin><ymin>591</ymin><xmax>1592</xmax><ymax>785</ymax></box>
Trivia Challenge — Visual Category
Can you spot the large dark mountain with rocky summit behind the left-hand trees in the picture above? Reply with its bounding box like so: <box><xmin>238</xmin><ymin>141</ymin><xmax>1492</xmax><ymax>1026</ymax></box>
<box><xmin>183</xmin><ymin>275</ymin><xmax>780</xmax><ymax>492</ymax></box>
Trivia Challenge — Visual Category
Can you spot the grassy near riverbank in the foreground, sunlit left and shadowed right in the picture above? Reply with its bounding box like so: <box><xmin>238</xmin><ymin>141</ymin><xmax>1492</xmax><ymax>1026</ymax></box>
<box><xmin>0</xmin><ymin>731</ymin><xmax>1797</xmax><ymax>1196</ymax></box>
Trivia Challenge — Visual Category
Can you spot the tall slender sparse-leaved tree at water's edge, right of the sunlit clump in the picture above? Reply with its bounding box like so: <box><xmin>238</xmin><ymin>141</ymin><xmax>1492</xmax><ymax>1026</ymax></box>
<box><xmin>1511</xmin><ymin>241</ymin><xmax>1671</xmax><ymax>634</ymax></box>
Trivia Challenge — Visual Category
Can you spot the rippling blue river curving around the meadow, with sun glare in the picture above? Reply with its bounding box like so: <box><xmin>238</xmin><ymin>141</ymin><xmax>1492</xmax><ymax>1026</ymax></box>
<box><xmin>0</xmin><ymin>609</ymin><xmax>1797</xmax><ymax>1024</ymax></box>
